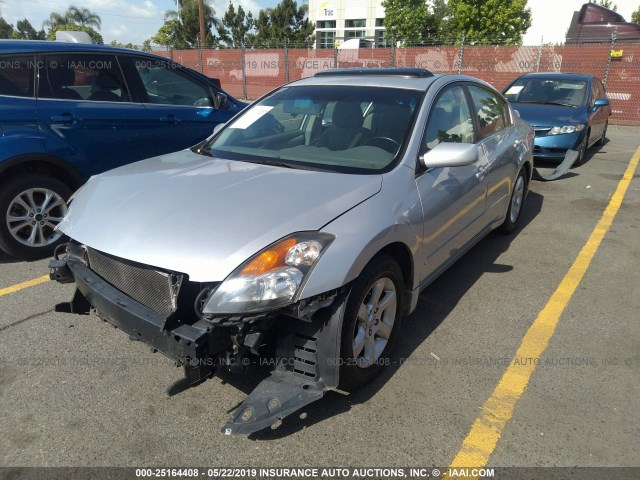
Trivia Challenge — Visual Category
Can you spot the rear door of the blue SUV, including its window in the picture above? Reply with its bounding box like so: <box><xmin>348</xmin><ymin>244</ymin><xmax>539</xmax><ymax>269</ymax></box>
<box><xmin>37</xmin><ymin>53</ymin><xmax>157</xmax><ymax>177</ymax></box>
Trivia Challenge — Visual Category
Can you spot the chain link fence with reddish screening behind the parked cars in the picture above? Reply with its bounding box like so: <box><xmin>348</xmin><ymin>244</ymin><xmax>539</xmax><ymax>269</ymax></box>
<box><xmin>155</xmin><ymin>37</ymin><xmax>640</xmax><ymax>125</ymax></box>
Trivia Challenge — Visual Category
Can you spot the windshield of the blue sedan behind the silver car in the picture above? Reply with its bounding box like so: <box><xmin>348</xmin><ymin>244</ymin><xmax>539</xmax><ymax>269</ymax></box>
<box><xmin>504</xmin><ymin>78</ymin><xmax>587</xmax><ymax>107</ymax></box>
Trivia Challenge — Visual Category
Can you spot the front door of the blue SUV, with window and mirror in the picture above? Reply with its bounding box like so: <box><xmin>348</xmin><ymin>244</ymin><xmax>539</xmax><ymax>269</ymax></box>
<box><xmin>124</xmin><ymin>56</ymin><xmax>229</xmax><ymax>154</ymax></box>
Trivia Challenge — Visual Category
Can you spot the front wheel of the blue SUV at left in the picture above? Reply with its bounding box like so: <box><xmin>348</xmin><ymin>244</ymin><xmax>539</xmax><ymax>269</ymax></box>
<box><xmin>0</xmin><ymin>174</ymin><xmax>71</xmax><ymax>260</ymax></box>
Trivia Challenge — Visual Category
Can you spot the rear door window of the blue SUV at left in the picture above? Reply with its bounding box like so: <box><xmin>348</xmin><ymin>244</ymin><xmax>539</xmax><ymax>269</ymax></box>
<box><xmin>38</xmin><ymin>55</ymin><xmax>131</xmax><ymax>102</ymax></box>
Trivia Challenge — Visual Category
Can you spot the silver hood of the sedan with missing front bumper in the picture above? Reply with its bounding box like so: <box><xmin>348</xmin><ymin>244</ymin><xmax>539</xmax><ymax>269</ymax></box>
<box><xmin>58</xmin><ymin>150</ymin><xmax>382</xmax><ymax>282</ymax></box>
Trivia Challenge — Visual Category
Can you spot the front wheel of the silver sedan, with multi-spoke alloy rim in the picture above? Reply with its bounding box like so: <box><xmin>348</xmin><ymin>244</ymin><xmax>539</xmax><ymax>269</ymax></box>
<box><xmin>340</xmin><ymin>255</ymin><xmax>404</xmax><ymax>391</ymax></box>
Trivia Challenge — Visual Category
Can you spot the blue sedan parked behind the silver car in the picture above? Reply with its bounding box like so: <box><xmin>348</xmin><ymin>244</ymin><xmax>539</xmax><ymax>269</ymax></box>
<box><xmin>503</xmin><ymin>73</ymin><xmax>611</xmax><ymax>165</ymax></box>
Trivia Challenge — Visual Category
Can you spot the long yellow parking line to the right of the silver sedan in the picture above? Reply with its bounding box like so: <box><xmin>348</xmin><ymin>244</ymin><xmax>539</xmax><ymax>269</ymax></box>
<box><xmin>449</xmin><ymin>147</ymin><xmax>640</xmax><ymax>472</ymax></box>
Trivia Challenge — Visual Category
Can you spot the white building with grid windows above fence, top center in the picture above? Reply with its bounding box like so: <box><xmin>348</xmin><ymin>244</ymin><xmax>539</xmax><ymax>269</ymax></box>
<box><xmin>309</xmin><ymin>0</ymin><xmax>385</xmax><ymax>48</ymax></box>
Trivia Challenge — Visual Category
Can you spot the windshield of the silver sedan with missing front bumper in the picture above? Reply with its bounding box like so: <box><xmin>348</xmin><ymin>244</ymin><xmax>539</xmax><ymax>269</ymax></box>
<box><xmin>202</xmin><ymin>85</ymin><xmax>423</xmax><ymax>173</ymax></box>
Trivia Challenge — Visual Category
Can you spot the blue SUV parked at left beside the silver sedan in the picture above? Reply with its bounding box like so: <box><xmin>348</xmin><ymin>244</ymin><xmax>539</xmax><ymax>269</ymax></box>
<box><xmin>0</xmin><ymin>40</ymin><xmax>246</xmax><ymax>259</ymax></box>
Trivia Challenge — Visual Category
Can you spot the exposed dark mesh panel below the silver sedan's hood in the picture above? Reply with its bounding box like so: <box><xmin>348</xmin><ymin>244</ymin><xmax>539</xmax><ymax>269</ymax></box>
<box><xmin>87</xmin><ymin>248</ymin><xmax>182</xmax><ymax>317</ymax></box>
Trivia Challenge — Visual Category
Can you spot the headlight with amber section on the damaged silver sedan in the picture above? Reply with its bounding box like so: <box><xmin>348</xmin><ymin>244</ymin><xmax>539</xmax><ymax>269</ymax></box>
<box><xmin>203</xmin><ymin>232</ymin><xmax>334</xmax><ymax>314</ymax></box>
